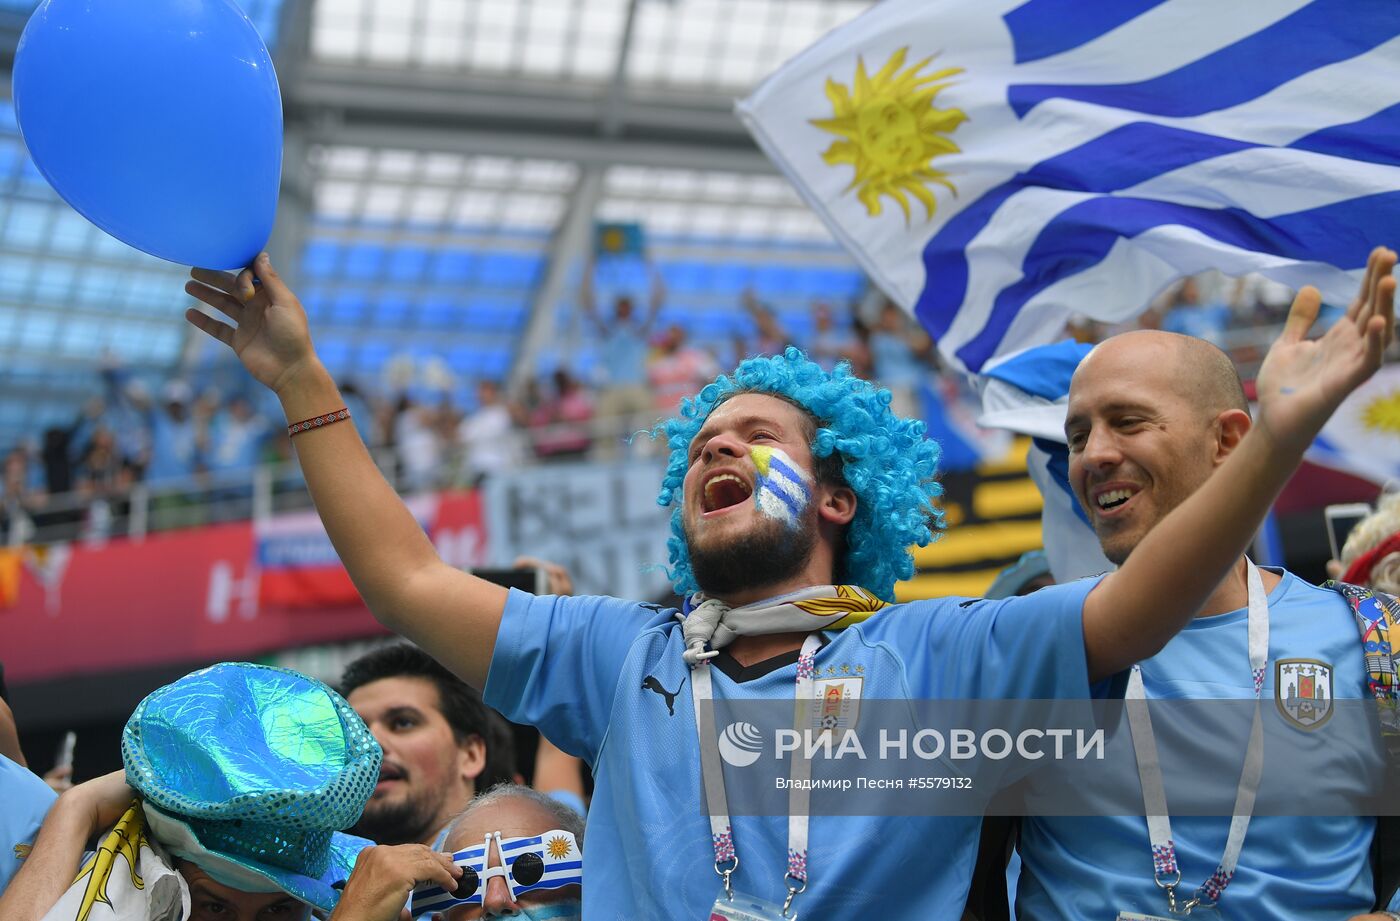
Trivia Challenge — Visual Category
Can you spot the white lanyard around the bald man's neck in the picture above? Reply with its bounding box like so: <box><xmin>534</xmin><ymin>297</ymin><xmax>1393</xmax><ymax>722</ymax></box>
<box><xmin>1126</xmin><ymin>558</ymin><xmax>1268</xmax><ymax>914</ymax></box>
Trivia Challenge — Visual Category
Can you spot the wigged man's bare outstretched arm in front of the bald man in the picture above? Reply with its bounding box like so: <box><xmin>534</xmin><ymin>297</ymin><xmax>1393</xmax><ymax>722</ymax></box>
<box><xmin>1084</xmin><ymin>249</ymin><xmax>1396</xmax><ymax>680</ymax></box>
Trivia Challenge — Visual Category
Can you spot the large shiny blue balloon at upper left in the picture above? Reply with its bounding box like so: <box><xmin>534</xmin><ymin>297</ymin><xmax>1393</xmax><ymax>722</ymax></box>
<box><xmin>13</xmin><ymin>0</ymin><xmax>281</xmax><ymax>269</ymax></box>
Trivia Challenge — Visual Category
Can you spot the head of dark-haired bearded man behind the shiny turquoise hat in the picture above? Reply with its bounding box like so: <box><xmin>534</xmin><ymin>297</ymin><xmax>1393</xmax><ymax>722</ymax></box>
<box><xmin>340</xmin><ymin>642</ymin><xmax>515</xmax><ymax>844</ymax></box>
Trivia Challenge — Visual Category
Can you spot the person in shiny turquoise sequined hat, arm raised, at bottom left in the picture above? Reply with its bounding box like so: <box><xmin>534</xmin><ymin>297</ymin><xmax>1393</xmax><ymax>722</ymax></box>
<box><xmin>0</xmin><ymin>663</ymin><xmax>414</xmax><ymax>921</ymax></box>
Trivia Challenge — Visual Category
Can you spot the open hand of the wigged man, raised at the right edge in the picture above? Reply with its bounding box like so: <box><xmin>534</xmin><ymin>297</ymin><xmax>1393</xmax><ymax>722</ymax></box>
<box><xmin>1256</xmin><ymin>246</ymin><xmax>1396</xmax><ymax>452</ymax></box>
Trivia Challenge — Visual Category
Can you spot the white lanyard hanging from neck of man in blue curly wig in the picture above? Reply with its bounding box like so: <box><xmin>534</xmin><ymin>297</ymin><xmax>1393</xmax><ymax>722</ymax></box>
<box><xmin>690</xmin><ymin>633</ymin><xmax>822</xmax><ymax>917</ymax></box>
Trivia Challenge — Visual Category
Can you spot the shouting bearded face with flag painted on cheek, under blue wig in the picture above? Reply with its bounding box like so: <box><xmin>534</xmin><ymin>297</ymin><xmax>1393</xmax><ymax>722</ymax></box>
<box><xmin>682</xmin><ymin>393</ymin><xmax>854</xmax><ymax>603</ymax></box>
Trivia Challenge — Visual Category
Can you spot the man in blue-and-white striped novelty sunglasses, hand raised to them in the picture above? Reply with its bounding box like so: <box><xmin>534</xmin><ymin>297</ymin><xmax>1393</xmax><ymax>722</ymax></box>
<box><xmin>330</xmin><ymin>784</ymin><xmax>584</xmax><ymax>921</ymax></box>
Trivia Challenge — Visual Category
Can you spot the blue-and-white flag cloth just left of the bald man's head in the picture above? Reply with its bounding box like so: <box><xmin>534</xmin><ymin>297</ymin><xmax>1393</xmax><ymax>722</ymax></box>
<box><xmin>977</xmin><ymin>342</ymin><xmax>1114</xmax><ymax>582</ymax></box>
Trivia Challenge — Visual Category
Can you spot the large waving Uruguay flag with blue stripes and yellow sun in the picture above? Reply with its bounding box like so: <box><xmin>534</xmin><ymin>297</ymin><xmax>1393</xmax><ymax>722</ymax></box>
<box><xmin>738</xmin><ymin>0</ymin><xmax>1400</xmax><ymax>371</ymax></box>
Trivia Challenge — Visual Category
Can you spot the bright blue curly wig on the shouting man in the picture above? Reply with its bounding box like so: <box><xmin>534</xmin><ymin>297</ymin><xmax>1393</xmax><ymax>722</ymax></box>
<box><xmin>654</xmin><ymin>346</ymin><xmax>944</xmax><ymax>600</ymax></box>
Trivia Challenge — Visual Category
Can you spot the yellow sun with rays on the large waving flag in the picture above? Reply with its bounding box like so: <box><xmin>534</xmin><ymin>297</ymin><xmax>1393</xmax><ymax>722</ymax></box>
<box><xmin>811</xmin><ymin>48</ymin><xmax>967</xmax><ymax>224</ymax></box>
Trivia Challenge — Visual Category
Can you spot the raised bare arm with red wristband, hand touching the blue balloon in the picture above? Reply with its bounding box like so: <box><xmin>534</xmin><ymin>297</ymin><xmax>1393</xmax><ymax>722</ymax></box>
<box><xmin>185</xmin><ymin>253</ymin><xmax>507</xmax><ymax>687</ymax></box>
